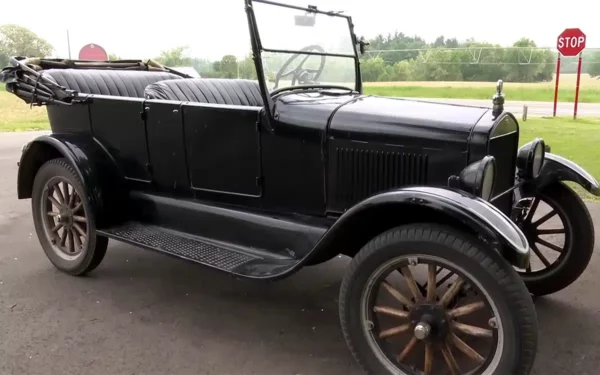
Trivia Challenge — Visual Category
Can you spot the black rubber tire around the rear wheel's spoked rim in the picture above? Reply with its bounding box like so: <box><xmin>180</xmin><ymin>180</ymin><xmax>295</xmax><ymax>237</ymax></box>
<box><xmin>31</xmin><ymin>158</ymin><xmax>108</xmax><ymax>276</ymax></box>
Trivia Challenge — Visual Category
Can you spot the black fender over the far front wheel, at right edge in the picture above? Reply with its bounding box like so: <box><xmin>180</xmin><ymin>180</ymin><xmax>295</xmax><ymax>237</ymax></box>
<box><xmin>536</xmin><ymin>152</ymin><xmax>600</xmax><ymax>196</ymax></box>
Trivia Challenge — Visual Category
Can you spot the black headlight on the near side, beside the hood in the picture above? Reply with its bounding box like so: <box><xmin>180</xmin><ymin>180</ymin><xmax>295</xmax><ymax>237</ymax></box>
<box><xmin>458</xmin><ymin>155</ymin><xmax>496</xmax><ymax>200</ymax></box>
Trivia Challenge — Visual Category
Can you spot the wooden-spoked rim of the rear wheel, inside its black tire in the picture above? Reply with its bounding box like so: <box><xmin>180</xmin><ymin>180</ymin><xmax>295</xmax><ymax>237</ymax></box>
<box><xmin>40</xmin><ymin>177</ymin><xmax>88</xmax><ymax>260</ymax></box>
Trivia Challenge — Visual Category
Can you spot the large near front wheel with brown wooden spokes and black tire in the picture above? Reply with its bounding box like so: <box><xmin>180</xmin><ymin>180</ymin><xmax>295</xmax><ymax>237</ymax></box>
<box><xmin>340</xmin><ymin>224</ymin><xmax>537</xmax><ymax>375</ymax></box>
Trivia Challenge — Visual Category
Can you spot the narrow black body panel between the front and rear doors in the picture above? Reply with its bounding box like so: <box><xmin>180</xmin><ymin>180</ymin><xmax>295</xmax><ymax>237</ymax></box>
<box><xmin>146</xmin><ymin>100</ymin><xmax>190</xmax><ymax>194</ymax></box>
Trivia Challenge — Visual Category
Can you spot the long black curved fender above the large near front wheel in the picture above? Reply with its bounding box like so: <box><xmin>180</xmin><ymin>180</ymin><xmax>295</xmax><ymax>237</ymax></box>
<box><xmin>313</xmin><ymin>186</ymin><xmax>530</xmax><ymax>268</ymax></box>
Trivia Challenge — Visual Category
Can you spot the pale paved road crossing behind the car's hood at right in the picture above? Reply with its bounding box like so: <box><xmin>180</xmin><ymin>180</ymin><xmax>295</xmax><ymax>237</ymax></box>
<box><xmin>414</xmin><ymin>98</ymin><xmax>600</xmax><ymax>119</ymax></box>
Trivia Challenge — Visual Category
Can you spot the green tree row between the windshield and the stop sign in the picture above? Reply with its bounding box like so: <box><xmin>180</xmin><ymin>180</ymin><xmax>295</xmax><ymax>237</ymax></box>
<box><xmin>361</xmin><ymin>33</ymin><xmax>555</xmax><ymax>82</ymax></box>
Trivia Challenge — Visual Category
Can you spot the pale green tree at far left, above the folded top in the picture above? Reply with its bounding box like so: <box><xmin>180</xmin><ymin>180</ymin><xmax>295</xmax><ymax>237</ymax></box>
<box><xmin>0</xmin><ymin>24</ymin><xmax>54</xmax><ymax>67</ymax></box>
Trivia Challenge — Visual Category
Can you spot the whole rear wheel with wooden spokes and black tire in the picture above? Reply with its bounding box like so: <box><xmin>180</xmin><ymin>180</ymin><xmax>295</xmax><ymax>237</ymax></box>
<box><xmin>31</xmin><ymin>159</ymin><xmax>108</xmax><ymax>276</ymax></box>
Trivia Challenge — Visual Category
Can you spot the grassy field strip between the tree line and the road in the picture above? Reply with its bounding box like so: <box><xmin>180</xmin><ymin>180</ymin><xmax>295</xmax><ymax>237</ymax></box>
<box><xmin>364</xmin><ymin>85</ymin><xmax>600</xmax><ymax>103</ymax></box>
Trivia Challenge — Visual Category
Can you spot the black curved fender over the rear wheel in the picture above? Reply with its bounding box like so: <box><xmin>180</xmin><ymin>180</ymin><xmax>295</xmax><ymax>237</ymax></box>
<box><xmin>17</xmin><ymin>133</ymin><xmax>126</xmax><ymax>227</ymax></box>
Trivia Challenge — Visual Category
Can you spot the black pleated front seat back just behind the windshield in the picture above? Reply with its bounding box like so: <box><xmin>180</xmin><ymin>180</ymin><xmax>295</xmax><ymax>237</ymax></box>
<box><xmin>145</xmin><ymin>78</ymin><xmax>263</xmax><ymax>107</ymax></box>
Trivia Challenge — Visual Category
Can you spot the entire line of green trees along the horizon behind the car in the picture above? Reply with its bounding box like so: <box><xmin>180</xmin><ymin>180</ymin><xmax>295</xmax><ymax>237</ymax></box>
<box><xmin>0</xmin><ymin>24</ymin><xmax>600</xmax><ymax>82</ymax></box>
